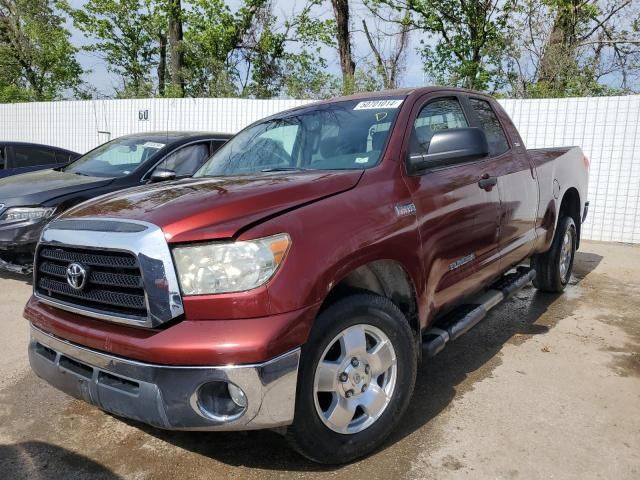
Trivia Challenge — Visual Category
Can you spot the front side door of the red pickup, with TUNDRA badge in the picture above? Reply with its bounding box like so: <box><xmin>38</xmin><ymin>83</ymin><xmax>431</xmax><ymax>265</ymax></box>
<box><xmin>405</xmin><ymin>94</ymin><xmax>500</xmax><ymax>316</ymax></box>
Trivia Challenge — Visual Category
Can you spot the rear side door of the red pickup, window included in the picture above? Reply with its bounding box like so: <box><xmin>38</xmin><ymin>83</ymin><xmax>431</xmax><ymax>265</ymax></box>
<box><xmin>468</xmin><ymin>96</ymin><xmax>538</xmax><ymax>269</ymax></box>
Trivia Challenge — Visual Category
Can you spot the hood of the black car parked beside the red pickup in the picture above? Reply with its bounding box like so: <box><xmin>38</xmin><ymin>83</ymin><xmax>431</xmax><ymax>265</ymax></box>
<box><xmin>0</xmin><ymin>169</ymin><xmax>113</xmax><ymax>207</ymax></box>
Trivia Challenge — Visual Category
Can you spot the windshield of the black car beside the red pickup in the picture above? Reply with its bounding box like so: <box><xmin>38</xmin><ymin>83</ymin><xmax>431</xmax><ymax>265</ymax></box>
<box><xmin>64</xmin><ymin>137</ymin><xmax>165</xmax><ymax>177</ymax></box>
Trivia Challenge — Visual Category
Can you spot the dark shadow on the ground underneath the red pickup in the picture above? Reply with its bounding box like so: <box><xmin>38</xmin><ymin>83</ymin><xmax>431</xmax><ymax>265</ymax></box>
<box><xmin>127</xmin><ymin>252</ymin><xmax>602</xmax><ymax>471</ymax></box>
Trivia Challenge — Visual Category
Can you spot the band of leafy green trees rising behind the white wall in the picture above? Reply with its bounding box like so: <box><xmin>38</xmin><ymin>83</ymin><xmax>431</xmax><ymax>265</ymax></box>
<box><xmin>0</xmin><ymin>0</ymin><xmax>640</xmax><ymax>102</ymax></box>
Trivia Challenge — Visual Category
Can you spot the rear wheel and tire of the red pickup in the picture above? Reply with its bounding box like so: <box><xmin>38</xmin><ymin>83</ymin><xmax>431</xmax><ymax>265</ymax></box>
<box><xmin>531</xmin><ymin>217</ymin><xmax>577</xmax><ymax>293</ymax></box>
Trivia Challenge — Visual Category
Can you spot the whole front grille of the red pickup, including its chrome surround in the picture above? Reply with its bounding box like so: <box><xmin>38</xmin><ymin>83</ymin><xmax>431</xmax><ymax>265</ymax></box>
<box><xmin>33</xmin><ymin>218</ymin><xmax>184</xmax><ymax>328</ymax></box>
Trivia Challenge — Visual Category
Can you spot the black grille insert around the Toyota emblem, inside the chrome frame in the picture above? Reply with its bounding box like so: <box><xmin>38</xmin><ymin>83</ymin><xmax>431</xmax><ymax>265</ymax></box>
<box><xmin>36</xmin><ymin>245</ymin><xmax>147</xmax><ymax>318</ymax></box>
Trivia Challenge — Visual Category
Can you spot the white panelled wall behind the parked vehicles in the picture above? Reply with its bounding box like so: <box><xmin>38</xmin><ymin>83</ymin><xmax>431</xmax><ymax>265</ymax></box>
<box><xmin>0</xmin><ymin>96</ymin><xmax>640</xmax><ymax>243</ymax></box>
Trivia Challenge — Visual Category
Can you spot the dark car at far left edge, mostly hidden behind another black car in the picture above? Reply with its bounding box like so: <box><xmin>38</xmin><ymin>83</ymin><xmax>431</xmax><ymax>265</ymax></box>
<box><xmin>0</xmin><ymin>142</ymin><xmax>80</xmax><ymax>178</ymax></box>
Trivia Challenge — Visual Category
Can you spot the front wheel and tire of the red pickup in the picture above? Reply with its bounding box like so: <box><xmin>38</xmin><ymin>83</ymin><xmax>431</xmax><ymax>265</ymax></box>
<box><xmin>286</xmin><ymin>293</ymin><xmax>418</xmax><ymax>464</ymax></box>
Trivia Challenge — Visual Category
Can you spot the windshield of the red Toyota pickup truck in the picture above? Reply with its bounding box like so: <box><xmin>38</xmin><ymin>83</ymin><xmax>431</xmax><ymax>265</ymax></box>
<box><xmin>195</xmin><ymin>97</ymin><xmax>403</xmax><ymax>177</ymax></box>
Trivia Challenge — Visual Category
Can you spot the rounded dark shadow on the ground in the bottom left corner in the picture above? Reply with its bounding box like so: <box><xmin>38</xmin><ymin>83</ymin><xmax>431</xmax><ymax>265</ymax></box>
<box><xmin>0</xmin><ymin>442</ymin><xmax>121</xmax><ymax>480</ymax></box>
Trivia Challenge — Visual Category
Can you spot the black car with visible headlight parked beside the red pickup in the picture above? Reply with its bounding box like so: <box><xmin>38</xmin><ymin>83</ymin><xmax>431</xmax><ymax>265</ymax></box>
<box><xmin>0</xmin><ymin>132</ymin><xmax>231</xmax><ymax>273</ymax></box>
